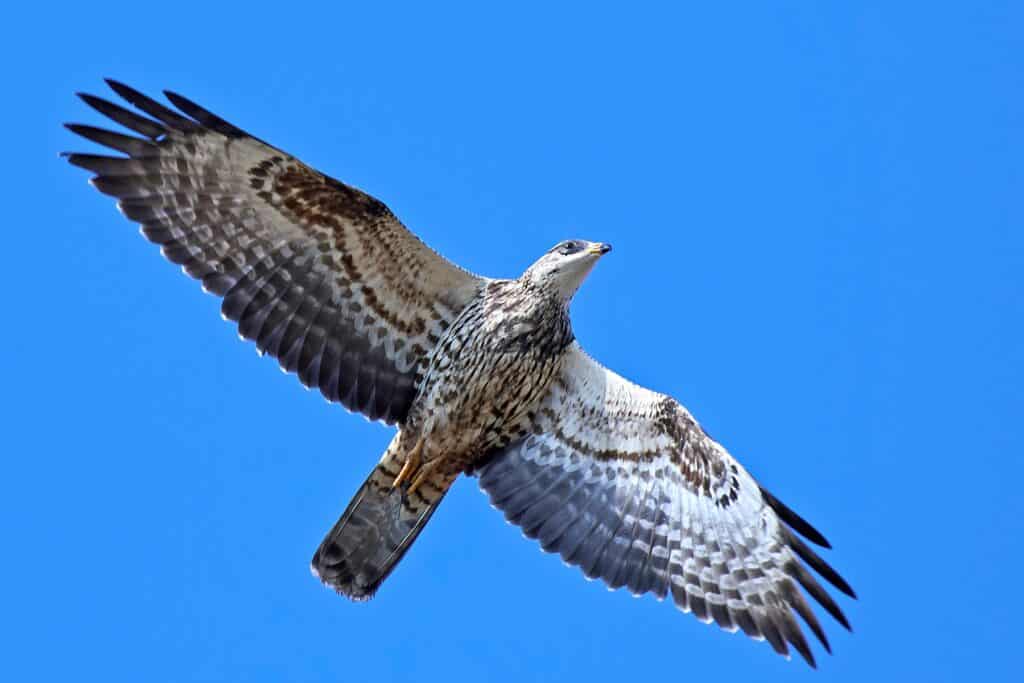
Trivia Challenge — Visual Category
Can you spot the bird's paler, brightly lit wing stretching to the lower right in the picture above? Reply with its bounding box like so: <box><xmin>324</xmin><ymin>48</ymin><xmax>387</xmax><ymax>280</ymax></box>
<box><xmin>477</xmin><ymin>345</ymin><xmax>853</xmax><ymax>666</ymax></box>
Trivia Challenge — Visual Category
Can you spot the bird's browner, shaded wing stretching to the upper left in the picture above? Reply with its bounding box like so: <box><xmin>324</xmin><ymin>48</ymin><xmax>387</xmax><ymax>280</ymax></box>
<box><xmin>67</xmin><ymin>81</ymin><xmax>482</xmax><ymax>423</ymax></box>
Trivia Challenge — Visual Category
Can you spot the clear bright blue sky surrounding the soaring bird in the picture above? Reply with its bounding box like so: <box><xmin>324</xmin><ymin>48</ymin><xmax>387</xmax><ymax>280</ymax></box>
<box><xmin>0</xmin><ymin>2</ymin><xmax>1024</xmax><ymax>683</ymax></box>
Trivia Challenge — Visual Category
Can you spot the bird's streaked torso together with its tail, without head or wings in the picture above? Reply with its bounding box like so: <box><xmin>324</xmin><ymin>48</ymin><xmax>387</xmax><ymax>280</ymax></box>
<box><xmin>312</xmin><ymin>278</ymin><xmax>572</xmax><ymax>599</ymax></box>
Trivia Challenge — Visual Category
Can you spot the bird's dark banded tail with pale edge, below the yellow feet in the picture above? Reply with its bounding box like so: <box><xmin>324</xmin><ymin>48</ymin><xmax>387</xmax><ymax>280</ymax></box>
<box><xmin>310</xmin><ymin>436</ymin><xmax>458</xmax><ymax>600</ymax></box>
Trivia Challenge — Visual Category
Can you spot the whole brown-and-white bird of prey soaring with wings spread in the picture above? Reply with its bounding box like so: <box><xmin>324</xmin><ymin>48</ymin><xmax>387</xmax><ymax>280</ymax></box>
<box><xmin>66</xmin><ymin>81</ymin><xmax>854</xmax><ymax>666</ymax></box>
